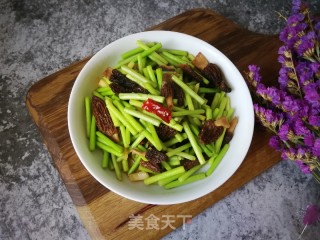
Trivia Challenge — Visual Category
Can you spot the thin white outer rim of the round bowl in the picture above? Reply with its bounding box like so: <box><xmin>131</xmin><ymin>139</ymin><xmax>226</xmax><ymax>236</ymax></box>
<box><xmin>67</xmin><ymin>30</ymin><xmax>254</xmax><ymax>205</ymax></box>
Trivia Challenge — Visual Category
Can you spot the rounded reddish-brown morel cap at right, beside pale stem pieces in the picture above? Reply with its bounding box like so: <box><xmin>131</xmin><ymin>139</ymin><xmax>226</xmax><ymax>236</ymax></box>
<box><xmin>199</xmin><ymin>119</ymin><xmax>224</xmax><ymax>144</ymax></box>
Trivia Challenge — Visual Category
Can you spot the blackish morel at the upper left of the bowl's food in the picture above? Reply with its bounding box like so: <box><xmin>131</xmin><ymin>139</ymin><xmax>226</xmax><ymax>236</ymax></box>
<box><xmin>109</xmin><ymin>69</ymin><xmax>147</xmax><ymax>94</ymax></box>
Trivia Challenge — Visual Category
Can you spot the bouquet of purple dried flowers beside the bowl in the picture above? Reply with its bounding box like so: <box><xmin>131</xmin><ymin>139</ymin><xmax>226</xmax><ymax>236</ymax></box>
<box><xmin>247</xmin><ymin>0</ymin><xmax>320</xmax><ymax>183</ymax></box>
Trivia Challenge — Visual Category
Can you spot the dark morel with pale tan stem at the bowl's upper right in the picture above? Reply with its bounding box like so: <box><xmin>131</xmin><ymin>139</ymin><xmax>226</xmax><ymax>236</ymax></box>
<box><xmin>192</xmin><ymin>52</ymin><xmax>231</xmax><ymax>92</ymax></box>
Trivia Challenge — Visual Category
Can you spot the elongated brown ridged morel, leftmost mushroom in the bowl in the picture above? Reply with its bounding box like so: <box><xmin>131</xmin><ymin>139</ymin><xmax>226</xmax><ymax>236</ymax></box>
<box><xmin>92</xmin><ymin>96</ymin><xmax>119</xmax><ymax>141</ymax></box>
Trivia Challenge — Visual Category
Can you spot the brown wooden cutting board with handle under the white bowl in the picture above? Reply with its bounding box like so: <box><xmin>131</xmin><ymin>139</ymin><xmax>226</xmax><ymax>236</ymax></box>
<box><xmin>26</xmin><ymin>9</ymin><xmax>280</xmax><ymax>239</ymax></box>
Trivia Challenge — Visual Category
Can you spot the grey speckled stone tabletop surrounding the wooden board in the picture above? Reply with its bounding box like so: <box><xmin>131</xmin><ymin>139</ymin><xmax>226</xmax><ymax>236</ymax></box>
<box><xmin>0</xmin><ymin>0</ymin><xmax>320</xmax><ymax>240</ymax></box>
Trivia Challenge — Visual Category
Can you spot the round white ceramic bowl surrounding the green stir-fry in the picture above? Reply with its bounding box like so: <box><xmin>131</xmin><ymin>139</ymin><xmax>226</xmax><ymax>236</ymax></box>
<box><xmin>68</xmin><ymin>31</ymin><xmax>254</xmax><ymax>205</ymax></box>
